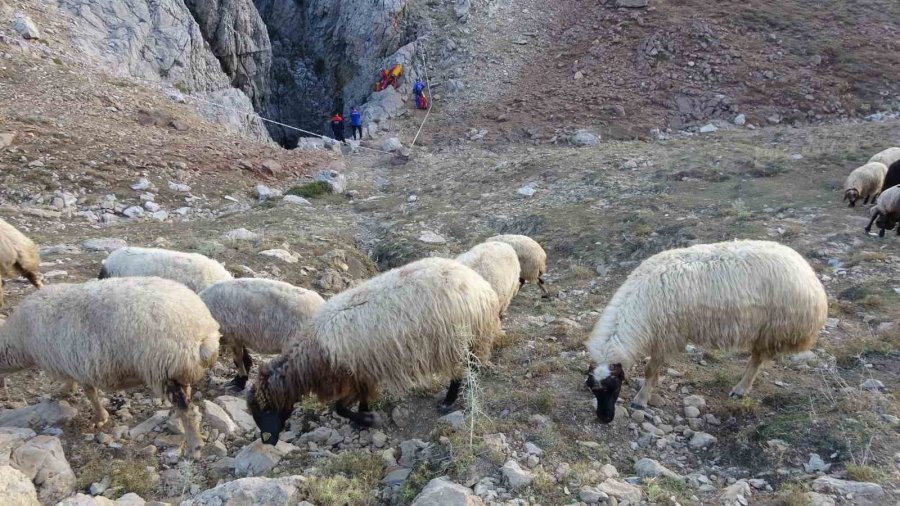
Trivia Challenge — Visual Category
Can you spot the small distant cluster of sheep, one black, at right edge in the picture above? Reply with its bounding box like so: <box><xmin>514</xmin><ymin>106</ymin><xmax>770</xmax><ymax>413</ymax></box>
<box><xmin>844</xmin><ymin>147</ymin><xmax>900</xmax><ymax>237</ymax></box>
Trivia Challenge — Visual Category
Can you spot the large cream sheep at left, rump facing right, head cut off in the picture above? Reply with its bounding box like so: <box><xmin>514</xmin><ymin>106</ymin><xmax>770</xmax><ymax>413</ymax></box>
<box><xmin>0</xmin><ymin>277</ymin><xmax>219</xmax><ymax>457</ymax></box>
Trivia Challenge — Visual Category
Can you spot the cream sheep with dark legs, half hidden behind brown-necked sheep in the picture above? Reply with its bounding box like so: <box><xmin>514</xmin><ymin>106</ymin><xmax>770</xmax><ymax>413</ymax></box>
<box><xmin>200</xmin><ymin>278</ymin><xmax>325</xmax><ymax>390</ymax></box>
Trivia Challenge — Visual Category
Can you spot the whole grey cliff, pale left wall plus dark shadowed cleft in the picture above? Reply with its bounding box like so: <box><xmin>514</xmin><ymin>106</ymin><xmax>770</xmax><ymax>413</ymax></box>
<box><xmin>56</xmin><ymin>0</ymin><xmax>428</xmax><ymax>146</ymax></box>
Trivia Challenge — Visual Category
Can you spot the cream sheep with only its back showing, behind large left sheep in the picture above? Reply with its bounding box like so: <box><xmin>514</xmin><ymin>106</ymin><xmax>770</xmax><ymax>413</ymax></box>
<box><xmin>98</xmin><ymin>247</ymin><xmax>232</xmax><ymax>293</ymax></box>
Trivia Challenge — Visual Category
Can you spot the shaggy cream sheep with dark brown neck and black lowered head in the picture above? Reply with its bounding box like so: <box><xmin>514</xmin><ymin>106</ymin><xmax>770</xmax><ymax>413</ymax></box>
<box><xmin>247</xmin><ymin>258</ymin><xmax>500</xmax><ymax>445</ymax></box>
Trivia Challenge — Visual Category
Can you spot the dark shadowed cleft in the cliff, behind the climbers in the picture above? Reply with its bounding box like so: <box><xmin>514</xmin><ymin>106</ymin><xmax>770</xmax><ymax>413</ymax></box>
<box><xmin>254</xmin><ymin>0</ymin><xmax>419</xmax><ymax>145</ymax></box>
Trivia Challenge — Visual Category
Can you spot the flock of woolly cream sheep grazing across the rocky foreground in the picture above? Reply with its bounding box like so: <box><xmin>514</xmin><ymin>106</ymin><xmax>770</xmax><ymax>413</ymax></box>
<box><xmin>0</xmin><ymin>180</ymin><xmax>840</xmax><ymax>458</ymax></box>
